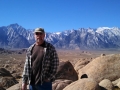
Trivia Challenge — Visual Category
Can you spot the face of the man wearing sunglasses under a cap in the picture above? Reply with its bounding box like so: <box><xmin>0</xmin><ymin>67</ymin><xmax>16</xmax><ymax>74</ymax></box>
<box><xmin>34</xmin><ymin>32</ymin><xmax>45</xmax><ymax>44</ymax></box>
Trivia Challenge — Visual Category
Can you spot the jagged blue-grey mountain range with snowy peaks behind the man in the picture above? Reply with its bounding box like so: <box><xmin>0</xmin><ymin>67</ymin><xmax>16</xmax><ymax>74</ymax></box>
<box><xmin>0</xmin><ymin>23</ymin><xmax>120</xmax><ymax>49</ymax></box>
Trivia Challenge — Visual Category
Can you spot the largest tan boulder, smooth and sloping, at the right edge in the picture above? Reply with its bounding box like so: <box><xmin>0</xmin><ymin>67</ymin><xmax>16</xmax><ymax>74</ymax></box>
<box><xmin>78</xmin><ymin>54</ymin><xmax>120</xmax><ymax>82</ymax></box>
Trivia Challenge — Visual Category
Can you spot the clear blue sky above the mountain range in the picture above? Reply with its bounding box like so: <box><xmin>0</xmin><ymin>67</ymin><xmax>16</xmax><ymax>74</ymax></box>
<box><xmin>0</xmin><ymin>0</ymin><xmax>120</xmax><ymax>32</ymax></box>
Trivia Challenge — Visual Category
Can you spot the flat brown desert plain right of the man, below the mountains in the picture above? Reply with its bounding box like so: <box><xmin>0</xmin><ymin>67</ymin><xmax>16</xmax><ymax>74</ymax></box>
<box><xmin>57</xmin><ymin>50</ymin><xmax>120</xmax><ymax>65</ymax></box>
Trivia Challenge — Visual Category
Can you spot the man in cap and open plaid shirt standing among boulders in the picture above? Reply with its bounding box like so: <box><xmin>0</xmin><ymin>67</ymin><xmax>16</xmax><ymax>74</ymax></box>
<box><xmin>22</xmin><ymin>28</ymin><xmax>59</xmax><ymax>90</ymax></box>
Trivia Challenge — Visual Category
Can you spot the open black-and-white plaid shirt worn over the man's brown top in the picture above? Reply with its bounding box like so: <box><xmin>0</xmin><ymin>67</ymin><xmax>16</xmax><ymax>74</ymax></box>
<box><xmin>22</xmin><ymin>41</ymin><xmax>59</xmax><ymax>84</ymax></box>
